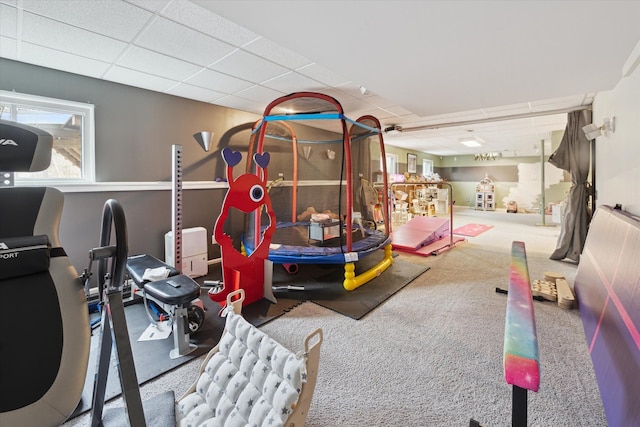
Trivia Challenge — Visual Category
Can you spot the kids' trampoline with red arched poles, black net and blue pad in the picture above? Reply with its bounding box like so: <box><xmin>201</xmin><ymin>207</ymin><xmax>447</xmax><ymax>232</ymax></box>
<box><xmin>242</xmin><ymin>92</ymin><xmax>393</xmax><ymax>290</ymax></box>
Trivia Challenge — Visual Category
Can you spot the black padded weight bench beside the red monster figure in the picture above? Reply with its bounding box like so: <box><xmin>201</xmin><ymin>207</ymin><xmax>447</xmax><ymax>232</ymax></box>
<box><xmin>127</xmin><ymin>254</ymin><xmax>204</xmax><ymax>359</ymax></box>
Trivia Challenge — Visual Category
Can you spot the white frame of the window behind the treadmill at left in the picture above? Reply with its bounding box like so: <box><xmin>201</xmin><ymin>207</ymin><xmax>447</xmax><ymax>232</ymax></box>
<box><xmin>0</xmin><ymin>90</ymin><xmax>95</xmax><ymax>186</ymax></box>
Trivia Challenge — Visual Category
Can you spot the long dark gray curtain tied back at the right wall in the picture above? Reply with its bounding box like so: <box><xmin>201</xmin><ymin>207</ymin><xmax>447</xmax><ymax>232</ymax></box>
<box><xmin>549</xmin><ymin>110</ymin><xmax>591</xmax><ymax>262</ymax></box>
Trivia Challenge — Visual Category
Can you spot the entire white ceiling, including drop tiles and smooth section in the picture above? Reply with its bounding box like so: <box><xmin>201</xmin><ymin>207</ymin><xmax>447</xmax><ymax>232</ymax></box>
<box><xmin>0</xmin><ymin>0</ymin><xmax>640</xmax><ymax>156</ymax></box>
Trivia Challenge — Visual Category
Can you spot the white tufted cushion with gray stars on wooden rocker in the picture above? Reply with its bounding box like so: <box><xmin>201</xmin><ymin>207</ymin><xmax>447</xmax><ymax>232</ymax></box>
<box><xmin>176</xmin><ymin>312</ymin><xmax>306</xmax><ymax>427</ymax></box>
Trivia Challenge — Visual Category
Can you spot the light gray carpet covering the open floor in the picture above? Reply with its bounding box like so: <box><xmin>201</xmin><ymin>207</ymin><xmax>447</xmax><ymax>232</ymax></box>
<box><xmin>67</xmin><ymin>211</ymin><xmax>607</xmax><ymax>427</ymax></box>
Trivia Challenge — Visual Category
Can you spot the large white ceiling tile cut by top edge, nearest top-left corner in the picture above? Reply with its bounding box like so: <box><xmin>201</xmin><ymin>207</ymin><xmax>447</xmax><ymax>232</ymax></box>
<box><xmin>22</xmin><ymin>0</ymin><xmax>153</xmax><ymax>42</ymax></box>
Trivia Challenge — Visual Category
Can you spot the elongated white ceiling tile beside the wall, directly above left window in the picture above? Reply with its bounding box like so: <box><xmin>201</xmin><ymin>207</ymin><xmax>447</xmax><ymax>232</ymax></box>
<box><xmin>15</xmin><ymin>43</ymin><xmax>110</xmax><ymax>79</ymax></box>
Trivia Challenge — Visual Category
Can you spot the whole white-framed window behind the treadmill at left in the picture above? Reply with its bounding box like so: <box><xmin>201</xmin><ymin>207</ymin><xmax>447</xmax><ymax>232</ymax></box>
<box><xmin>0</xmin><ymin>91</ymin><xmax>95</xmax><ymax>185</ymax></box>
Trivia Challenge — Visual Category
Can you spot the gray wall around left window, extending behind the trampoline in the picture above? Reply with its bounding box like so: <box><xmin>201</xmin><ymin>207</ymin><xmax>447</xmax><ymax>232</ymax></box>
<box><xmin>0</xmin><ymin>58</ymin><xmax>358</xmax><ymax>271</ymax></box>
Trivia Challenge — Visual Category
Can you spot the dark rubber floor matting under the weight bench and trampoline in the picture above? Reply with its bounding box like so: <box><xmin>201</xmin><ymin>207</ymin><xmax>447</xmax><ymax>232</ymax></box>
<box><xmin>69</xmin><ymin>252</ymin><xmax>428</xmax><ymax>416</ymax></box>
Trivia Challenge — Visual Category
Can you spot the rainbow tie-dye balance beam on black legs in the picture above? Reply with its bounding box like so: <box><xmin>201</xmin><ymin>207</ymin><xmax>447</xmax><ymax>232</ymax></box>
<box><xmin>503</xmin><ymin>242</ymin><xmax>540</xmax><ymax>426</ymax></box>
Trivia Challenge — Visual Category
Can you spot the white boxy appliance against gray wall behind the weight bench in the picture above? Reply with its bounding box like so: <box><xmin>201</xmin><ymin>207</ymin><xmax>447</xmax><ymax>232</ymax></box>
<box><xmin>164</xmin><ymin>227</ymin><xmax>209</xmax><ymax>277</ymax></box>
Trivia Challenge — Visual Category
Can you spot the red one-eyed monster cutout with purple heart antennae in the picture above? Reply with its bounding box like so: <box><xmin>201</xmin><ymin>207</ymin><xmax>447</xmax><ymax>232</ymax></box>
<box><xmin>209</xmin><ymin>147</ymin><xmax>276</xmax><ymax>305</ymax></box>
